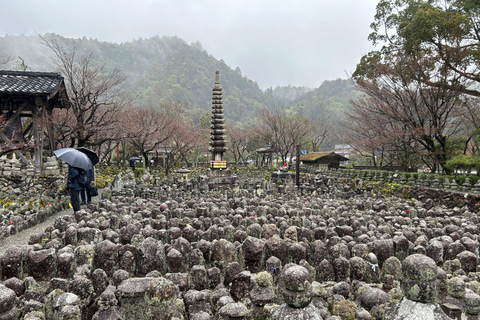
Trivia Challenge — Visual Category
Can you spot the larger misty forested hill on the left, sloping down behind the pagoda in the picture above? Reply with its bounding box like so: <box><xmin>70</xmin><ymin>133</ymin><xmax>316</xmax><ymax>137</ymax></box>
<box><xmin>0</xmin><ymin>35</ymin><xmax>276</xmax><ymax>123</ymax></box>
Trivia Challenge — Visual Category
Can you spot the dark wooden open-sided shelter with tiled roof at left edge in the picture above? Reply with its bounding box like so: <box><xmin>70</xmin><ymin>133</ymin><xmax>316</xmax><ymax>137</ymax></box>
<box><xmin>0</xmin><ymin>70</ymin><xmax>68</xmax><ymax>172</ymax></box>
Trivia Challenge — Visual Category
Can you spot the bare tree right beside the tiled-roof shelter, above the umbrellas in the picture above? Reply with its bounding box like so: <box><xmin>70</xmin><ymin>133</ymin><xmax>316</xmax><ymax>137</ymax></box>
<box><xmin>40</xmin><ymin>36</ymin><xmax>130</xmax><ymax>146</ymax></box>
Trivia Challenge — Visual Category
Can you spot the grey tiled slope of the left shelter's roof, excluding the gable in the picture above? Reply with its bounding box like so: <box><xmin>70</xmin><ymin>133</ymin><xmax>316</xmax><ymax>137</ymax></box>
<box><xmin>0</xmin><ymin>70</ymin><xmax>63</xmax><ymax>95</ymax></box>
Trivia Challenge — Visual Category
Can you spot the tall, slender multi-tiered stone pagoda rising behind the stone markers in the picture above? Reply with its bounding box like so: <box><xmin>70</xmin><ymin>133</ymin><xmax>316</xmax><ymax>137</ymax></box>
<box><xmin>206</xmin><ymin>70</ymin><xmax>237</xmax><ymax>190</ymax></box>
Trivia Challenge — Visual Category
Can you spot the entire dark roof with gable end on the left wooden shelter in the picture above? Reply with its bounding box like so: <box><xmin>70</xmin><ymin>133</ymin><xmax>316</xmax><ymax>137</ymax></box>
<box><xmin>0</xmin><ymin>70</ymin><xmax>68</xmax><ymax>108</ymax></box>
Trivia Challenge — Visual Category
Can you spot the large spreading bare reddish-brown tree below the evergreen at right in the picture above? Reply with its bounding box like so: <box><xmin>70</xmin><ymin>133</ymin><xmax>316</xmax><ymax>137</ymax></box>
<box><xmin>350</xmin><ymin>57</ymin><xmax>465</xmax><ymax>171</ymax></box>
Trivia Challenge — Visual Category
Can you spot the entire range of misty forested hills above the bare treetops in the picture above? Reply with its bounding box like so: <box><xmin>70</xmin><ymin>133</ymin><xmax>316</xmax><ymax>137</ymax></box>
<box><xmin>0</xmin><ymin>35</ymin><xmax>355</xmax><ymax>136</ymax></box>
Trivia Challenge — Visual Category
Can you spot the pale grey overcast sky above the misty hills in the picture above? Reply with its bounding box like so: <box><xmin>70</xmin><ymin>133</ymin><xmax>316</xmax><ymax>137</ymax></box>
<box><xmin>0</xmin><ymin>0</ymin><xmax>378</xmax><ymax>89</ymax></box>
